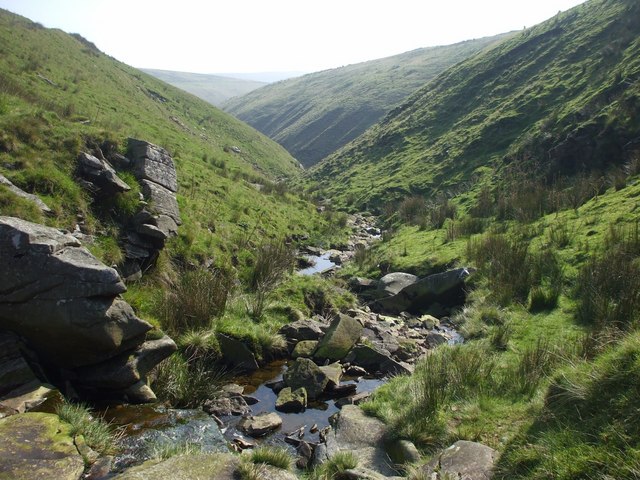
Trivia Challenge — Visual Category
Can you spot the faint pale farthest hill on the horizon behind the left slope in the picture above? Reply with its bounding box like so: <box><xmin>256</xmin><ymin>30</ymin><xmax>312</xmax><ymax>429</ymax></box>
<box><xmin>142</xmin><ymin>68</ymin><xmax>267</xmax><ymax>107</ymax></box>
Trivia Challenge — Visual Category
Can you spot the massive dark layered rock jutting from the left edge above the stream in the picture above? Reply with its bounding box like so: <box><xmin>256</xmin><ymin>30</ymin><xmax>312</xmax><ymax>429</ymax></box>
<box><xmin>0</xmin><ymin>217</ymin><xmax>176</xmax><ymax>401</ymax></box>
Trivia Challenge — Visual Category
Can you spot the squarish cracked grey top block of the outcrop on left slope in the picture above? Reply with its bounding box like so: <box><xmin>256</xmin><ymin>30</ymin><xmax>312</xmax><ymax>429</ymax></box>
<box><xmin>127</xmin><ymin>138</ymin><xmax>178</xmax><ymax>192</ymax></box>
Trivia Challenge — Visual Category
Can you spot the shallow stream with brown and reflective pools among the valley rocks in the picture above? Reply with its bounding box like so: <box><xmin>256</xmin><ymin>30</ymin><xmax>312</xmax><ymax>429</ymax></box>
<box><xmin>102</xmin><ymin>217</ymin><xmax>463</xmax><ymax>471</ymax></box>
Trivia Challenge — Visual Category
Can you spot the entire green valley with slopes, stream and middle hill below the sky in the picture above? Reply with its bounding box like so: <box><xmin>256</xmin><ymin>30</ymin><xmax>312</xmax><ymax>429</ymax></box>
<box><xmin>0</xmin><ymin>0</ymin><xmax>640</xmax><ymax>480</ymax></box>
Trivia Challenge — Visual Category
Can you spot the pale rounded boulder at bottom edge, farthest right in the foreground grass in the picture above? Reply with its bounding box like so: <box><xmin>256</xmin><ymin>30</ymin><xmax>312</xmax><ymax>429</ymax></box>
<box><xmin>421</xmin><ymin>440</ymin><xmax>498</xmax><ymax>480</ymax></box>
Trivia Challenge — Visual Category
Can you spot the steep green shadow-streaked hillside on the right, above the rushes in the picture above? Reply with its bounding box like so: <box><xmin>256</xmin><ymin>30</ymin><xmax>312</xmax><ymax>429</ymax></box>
<box><xmin>309</xmin><ymin>0</ymin><xmax>640</xmax><ymax>209</ymax></box>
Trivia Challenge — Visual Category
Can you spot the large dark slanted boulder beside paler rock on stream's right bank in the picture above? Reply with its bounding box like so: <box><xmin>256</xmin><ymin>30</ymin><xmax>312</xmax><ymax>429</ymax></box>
<box><xmin>372</xmin><ymin>268</ymin><xmax>473</xmax><ymax>314</ymax></box>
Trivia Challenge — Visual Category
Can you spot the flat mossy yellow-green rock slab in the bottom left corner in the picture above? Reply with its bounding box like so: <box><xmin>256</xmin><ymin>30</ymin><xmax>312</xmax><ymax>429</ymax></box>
<box><xmin>0</xmin><ymin>413</ymin><xmax>84</xmax><ymax>480</ymax></box>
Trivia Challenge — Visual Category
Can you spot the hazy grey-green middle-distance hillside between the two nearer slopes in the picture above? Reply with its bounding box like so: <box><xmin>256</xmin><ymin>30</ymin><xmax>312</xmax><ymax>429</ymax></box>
<box><xmin>224</xmin><ymin>35</ymin><xmax>510</xmax><ymax>166</ymax></box>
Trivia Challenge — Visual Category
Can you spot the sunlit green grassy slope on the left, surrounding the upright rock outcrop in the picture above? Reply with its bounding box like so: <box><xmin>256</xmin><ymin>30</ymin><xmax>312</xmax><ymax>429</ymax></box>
<box><xmin>0</xmin><ymin>7</ymin><xmax>336</xmax><ymax>258</ymax></box>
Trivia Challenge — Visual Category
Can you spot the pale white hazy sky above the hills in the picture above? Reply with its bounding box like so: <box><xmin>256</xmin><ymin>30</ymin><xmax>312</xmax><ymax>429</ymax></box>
<box><xmin>0</xmin><ymin>0</ymin><xmax>584</xmax><ymax>73</ymax></box>
